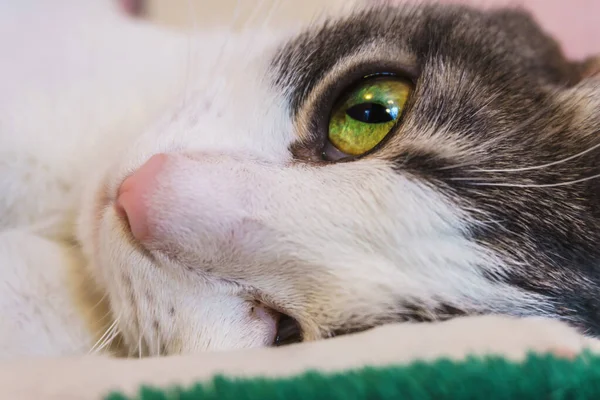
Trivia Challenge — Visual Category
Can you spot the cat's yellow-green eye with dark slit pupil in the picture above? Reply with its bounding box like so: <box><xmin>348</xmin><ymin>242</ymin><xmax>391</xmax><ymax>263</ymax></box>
<box><xmin>329</xmin><ymin>77</ymin><xmax>411</xmax><ymax>156</ymax></box>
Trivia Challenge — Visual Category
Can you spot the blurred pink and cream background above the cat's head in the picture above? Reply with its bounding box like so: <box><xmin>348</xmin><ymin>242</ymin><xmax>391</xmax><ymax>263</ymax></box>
<box><xmin>135</xmin><ymin>0</ymin><xmax>600</xmax><ymax>58</ymax></box>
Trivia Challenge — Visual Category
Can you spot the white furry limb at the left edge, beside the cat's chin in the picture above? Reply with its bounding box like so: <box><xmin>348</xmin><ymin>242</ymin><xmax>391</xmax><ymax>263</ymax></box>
<box><xmin>0</xmin><ymin>230</ymin><xmax>92</xmax><ymax>358</ymax></box>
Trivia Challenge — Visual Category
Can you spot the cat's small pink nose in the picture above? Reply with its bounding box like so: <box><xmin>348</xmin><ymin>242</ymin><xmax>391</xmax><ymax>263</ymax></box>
<box><xmin>116</xmin><ymin>154</ymin><xmax>167</xmax><ymax>241</ymax></box>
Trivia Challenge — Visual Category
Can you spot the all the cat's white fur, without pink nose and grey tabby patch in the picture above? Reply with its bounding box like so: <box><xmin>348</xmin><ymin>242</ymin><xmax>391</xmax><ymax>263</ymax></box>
<box><xmin>0</xmin><ymin>0</ymin><xmax>596</xmax><ymax>358</ymax></box>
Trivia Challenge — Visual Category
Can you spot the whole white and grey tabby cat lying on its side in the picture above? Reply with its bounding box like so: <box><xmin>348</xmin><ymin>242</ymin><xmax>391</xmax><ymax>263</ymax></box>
<box><xmin>0</xmin><ymin>0</ymin><xmax>600</xmax><ymax>359</ymax></box>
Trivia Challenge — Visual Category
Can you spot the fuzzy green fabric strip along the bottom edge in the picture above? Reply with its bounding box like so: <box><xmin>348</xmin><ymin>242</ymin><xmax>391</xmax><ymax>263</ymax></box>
<box><xmin>106</xmin><ymin>354</ymin><xmax>600</xmax><ymax>400</ymax></box>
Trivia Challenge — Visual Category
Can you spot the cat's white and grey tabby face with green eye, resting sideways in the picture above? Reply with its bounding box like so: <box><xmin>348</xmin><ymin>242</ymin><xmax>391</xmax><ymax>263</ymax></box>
<box><xmin>81</xmin><ymin>1</ymin><xmax>600</xmax><ymax>354</ymax></box>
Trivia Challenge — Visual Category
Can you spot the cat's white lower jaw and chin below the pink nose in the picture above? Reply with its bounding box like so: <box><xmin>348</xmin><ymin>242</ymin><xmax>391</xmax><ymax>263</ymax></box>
<box><xmin>97</xmin><ymin>219</ymin><xmax>278</xmax><ymax>356</ymax></box>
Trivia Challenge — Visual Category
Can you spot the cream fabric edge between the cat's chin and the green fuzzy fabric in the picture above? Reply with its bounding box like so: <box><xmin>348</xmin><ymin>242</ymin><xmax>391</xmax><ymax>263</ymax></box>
<box><xmin>0</xmin><ymin>316</ymin><xmax>598</xmax><ymax>400</ymax></box>
